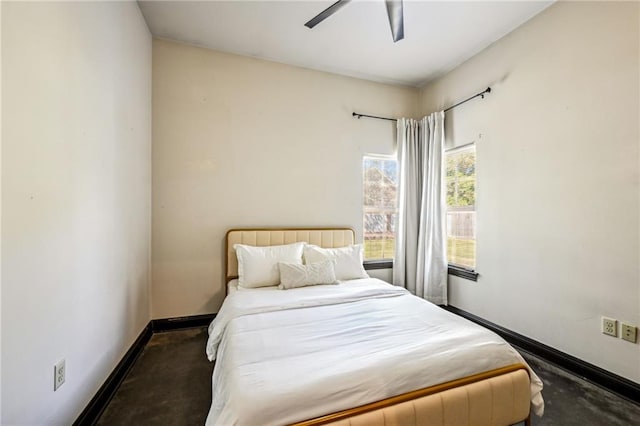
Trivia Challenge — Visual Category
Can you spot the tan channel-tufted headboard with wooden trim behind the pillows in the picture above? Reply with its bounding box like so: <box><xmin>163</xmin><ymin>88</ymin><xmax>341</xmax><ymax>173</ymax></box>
<box><xmin>225</xmin><ymin>228</ymin><xmax>356</xmax><ymax>282</ymax></box>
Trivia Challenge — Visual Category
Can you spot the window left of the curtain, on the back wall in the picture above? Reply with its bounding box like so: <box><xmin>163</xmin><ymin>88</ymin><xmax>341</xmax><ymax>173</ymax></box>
<box><xmin>362</xmin><ymin>157</ymin><xmax>398</xmax><ymax>260</ymax></box>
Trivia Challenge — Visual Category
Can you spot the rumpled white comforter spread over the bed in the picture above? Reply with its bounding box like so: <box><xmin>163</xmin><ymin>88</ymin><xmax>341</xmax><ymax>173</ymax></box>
<box><xmin>206</xmin><ymin>279</ymin><xmax>544</xmax><ymax>425</ymax></box>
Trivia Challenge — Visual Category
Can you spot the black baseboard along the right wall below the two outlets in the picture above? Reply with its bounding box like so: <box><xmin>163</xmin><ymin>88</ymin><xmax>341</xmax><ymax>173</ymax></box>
<box><xmin>442</xmin><ymin>306</ymin><xmax>640</xmax><ymax>403</ymax></box>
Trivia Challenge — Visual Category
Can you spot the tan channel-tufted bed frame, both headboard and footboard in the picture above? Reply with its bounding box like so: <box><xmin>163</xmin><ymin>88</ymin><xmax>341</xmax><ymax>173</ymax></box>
<box><xmin>225</xmin><ymin>228</ymin><xmax>531</xmax><ymax>426</ymax></box>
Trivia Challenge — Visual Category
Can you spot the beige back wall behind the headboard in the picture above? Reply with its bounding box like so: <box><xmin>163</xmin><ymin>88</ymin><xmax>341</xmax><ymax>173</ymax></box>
<box><xmin>152</xmin><ymin>40</ymin><xmax>417</xmax><ymax>318</ymax></box>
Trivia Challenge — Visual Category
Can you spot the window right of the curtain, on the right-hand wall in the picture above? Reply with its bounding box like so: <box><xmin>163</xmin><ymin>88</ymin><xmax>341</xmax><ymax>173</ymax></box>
<box><xmin>445</xmin><ymin>144</ymin><xmax>476</xmax><ymax>270</ymax></box>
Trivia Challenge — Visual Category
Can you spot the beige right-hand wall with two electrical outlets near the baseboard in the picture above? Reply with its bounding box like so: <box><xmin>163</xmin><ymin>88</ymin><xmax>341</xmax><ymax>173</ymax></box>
<box><xmin>420</xmin><ymin>2</ymin><xmax>640</xmax><ymax>382</ymax></box>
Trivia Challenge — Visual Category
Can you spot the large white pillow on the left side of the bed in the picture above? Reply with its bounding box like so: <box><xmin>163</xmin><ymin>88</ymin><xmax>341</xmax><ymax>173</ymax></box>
<box><xmin>233</xmin><ymin>243</ymin><xmax>305</xmax><ymax>288</ymax></box>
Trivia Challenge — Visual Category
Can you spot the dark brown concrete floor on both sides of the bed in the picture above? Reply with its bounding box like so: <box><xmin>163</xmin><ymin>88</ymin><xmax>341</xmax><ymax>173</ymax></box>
<box><xmin>98</xmin><ymin>328</ymin><xmax>640</xmax><ymax>426</ymax></box>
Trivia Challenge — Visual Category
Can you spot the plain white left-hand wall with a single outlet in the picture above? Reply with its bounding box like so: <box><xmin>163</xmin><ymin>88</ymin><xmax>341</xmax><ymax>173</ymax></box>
<box><xmin>1</xmin><ymin>2</ymin><xmax>151</xmax><ymax>425</ymax></box>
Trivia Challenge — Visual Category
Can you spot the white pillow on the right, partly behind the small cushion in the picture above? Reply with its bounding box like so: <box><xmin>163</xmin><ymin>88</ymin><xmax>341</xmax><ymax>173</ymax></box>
<box><xmin>304</xmin><ymin>244</ymin><xmax>369</xmax><ymax>280</ymax></box>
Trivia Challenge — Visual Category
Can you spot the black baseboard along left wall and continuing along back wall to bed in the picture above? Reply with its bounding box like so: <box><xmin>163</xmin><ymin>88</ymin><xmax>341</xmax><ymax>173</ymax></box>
<box><xmin>73</xmin><ymin>314</ymin><xmax>216</xmax><ymax>426</ymax></box>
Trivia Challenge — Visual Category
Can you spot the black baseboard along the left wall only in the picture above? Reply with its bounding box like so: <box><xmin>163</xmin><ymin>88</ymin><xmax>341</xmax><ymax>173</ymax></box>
<box><xmin>73</xmin><ymin>323</ymin><xmax>153</xmax><ymax>426</ymax></box>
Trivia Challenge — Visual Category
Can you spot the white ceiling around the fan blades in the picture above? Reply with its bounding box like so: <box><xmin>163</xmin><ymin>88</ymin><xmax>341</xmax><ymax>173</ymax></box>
<box><xmin>138</xmin><ymin>0</ymin><xmax>553</xmax><ymax>86</ymax></box>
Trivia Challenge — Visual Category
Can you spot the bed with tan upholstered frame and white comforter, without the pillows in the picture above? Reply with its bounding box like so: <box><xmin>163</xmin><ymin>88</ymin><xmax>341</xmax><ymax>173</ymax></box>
<box><xmin>207</xmin><ymin>228</ymin><xmax>544</xmax><ymax>426</ymax></box>
